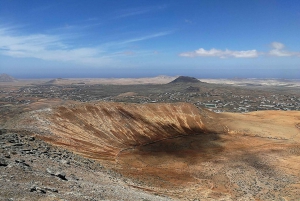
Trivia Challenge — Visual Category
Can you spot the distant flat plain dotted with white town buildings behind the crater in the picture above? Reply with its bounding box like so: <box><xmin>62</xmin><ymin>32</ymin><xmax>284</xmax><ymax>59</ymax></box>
<box><xmin>0</xmin><ymin>76</ymin><xmax>300</xmax><ymax>113</ymax></box>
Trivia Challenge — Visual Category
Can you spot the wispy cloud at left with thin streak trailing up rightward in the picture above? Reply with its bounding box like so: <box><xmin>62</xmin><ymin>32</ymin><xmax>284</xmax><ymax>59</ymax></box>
<box><xmin>0</xmin><ymin>27</ymin><xmax>171</xmax><ymax>66</ymax></box>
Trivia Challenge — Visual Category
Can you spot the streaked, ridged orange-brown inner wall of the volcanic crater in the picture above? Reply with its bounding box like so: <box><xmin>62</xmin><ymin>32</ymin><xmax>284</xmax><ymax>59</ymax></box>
<box><xmin>17</xmin><ymin>102</ymin><xmax>217</xmax><ymax>159</ymax></box>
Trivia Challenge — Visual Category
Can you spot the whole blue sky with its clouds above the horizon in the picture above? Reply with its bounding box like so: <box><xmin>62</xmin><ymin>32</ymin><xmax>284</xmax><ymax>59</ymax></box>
<box><xmin>0</xmin><ymin>0</ymin><xmax>300</xmax><ymax>79</ymax></box>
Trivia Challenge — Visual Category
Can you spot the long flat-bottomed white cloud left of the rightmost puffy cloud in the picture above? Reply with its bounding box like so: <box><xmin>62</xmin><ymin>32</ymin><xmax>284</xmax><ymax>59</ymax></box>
<box><xmin>179</xmin><ymin>48</ymin><xmax>258</xmax><ymax>58</ymax></box>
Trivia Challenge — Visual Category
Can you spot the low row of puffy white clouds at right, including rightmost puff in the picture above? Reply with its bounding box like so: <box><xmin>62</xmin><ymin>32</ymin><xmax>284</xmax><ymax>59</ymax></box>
<box><xmin>179</xmin><ymin>42</ymin><xmax>300</xmax><ymax>58</ymax></box>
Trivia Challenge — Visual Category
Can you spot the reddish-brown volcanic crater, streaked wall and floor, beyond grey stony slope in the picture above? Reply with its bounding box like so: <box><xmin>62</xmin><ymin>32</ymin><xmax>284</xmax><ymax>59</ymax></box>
<box><xmin>7</xmin><ymin>102</ymin><xmax>300</xmax><ymax>200</ymax></box>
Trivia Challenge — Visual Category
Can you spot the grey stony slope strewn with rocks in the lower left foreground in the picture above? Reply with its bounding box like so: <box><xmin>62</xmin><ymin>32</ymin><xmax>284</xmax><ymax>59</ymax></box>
<box><xmin>0</xmin><ymin>130</ymin><xmax>175</xmax><ymax>201</ymax></box>
